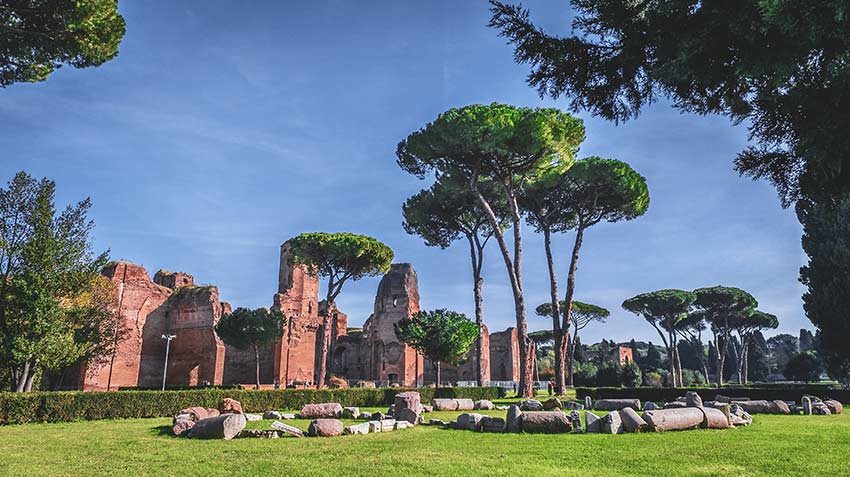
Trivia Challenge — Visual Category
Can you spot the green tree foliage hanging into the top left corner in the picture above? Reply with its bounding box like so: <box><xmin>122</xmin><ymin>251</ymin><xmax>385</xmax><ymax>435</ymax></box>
<box><xmin>0</xmin><ymin>0</ymin><xmax>124</xmax><ymax>88</ymax></box>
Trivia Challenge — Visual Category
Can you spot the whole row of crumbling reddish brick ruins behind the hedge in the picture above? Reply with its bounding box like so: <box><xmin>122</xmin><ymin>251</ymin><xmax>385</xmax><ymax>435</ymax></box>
<box><xmin>68</xmin><ymin>242</ymin><xmax>519</xmax><ymax>391</ymax></box>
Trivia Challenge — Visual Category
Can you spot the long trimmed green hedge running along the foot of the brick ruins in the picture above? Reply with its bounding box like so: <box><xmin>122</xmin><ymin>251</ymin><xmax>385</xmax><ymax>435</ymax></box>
<box><xmin>0</xmin><ymin>387</ymin><xmax>505</xmax><ymax>424</ymax></box>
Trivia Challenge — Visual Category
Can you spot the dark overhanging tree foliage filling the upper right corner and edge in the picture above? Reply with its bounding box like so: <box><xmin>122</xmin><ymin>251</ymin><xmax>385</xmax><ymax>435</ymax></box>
<box><xmin>490</xmin><ymin>0</ymin><xmax>850</xmax><ymax>376</ymax></box>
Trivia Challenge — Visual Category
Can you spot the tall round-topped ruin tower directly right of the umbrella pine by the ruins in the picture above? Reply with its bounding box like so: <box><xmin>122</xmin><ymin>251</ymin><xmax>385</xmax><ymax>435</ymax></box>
<box><xmin>364</xmin><ymin>263</ymin><xmax>425</xmax><ymax>386</ymax></box>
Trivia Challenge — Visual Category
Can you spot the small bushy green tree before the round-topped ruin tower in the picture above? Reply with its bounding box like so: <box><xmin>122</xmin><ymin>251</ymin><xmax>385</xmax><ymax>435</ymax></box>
<box><xmin>395</xmin><ymin>309</ymin><xmax>478</xmax><ymax>387</ymax></box>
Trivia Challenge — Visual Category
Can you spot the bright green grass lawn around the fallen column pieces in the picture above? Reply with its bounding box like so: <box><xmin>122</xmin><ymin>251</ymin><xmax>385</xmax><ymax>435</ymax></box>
<box><xmin>0</xmin><ymin>394</ymin><xmax>850</xmax><ymax>477</ymax></box>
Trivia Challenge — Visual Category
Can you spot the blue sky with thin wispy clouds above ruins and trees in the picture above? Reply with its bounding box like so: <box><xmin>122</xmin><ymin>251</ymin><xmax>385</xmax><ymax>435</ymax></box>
<box><xmin>0</xmin><ymin>0</ymin><xmax>811</xmax><ymax>342</ymax></box>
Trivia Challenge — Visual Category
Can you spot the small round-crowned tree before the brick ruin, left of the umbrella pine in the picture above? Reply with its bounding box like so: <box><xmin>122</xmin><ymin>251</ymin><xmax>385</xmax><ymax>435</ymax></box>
<box><xmin>215</xmin><ymin>308</ymin><xmax>286</xmax><ymax>388</ymax></box>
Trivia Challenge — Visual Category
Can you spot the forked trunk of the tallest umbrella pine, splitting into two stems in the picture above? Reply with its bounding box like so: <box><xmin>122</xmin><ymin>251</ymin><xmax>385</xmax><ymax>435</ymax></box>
<box><xmin>470</xmin><ymin>177</ymin><xmax>534</xmax><ymax>397</ymax></box>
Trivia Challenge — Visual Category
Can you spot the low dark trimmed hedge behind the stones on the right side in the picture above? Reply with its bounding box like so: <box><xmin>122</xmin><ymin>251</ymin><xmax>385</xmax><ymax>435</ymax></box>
<box><xmin>576</xmin><ymin>385</ymin><xmax>850</xmax><ymax>403</ymax></box>
